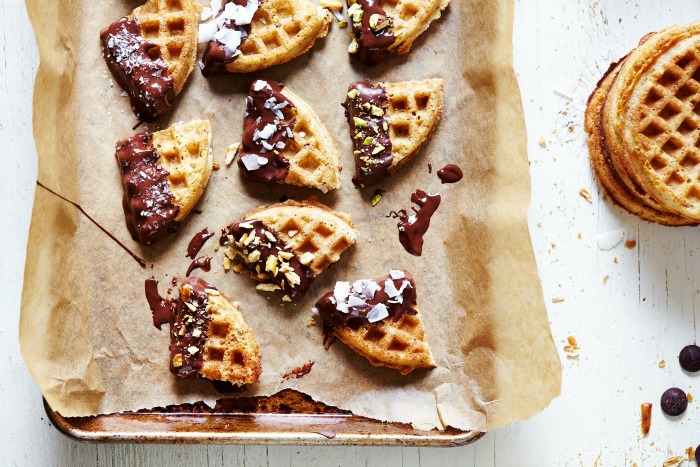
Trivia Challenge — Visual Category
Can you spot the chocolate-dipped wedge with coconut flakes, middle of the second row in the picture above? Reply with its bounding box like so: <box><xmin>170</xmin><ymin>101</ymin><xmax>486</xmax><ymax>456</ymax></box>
<box><xmin>238</xmin><ymin>79</ymin><xmax>340</xmax><ymax>193</ymax></box>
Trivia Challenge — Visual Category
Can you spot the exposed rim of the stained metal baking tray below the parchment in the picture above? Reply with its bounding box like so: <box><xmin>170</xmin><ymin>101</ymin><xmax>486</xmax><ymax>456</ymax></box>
<box><xmin>44</xmin><ymin>389</ymin><xmax>484</xmax><ymax>447</ymax></box>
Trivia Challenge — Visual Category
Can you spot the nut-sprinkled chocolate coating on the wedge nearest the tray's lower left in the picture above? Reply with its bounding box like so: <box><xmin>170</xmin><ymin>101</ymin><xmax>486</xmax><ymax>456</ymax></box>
<box><xmin>170</xmin><ymin>277</ymin><xmax>217</xmax><ymax>378</ymax></box>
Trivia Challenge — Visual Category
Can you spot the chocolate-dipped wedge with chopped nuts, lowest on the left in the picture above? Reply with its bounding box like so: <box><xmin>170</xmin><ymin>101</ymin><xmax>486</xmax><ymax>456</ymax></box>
<box><xmin>170</xmin><ymin>277</ymin><xmax>262</xmax><ymax>385</ymax></box>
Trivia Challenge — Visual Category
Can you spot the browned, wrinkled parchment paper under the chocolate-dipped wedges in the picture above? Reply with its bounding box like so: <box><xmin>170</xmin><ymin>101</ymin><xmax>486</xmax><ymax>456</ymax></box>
<box><xmin>20</xmin><ymin>0</ymin><xmax>561</xmax><ymax>430</ymax></box>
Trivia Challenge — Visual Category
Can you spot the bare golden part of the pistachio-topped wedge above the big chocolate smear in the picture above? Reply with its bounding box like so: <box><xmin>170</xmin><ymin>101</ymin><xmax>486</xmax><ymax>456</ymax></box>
<box><xmin>383</xmin><ymin>79</ymin><xmax>444</xmax><ymax>173</ymax></box>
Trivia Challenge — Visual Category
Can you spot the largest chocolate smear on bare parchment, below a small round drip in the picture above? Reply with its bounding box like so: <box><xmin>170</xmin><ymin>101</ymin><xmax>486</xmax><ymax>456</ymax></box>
<box><xmin>387</xmin><ymin>190</ymin><xmax>440</xmax><ymax>256</ymax></box>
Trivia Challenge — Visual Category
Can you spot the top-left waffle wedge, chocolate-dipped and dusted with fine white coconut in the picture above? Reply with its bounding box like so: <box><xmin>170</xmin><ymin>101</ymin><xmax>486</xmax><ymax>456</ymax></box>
<box><xmin>100</xmin><ymin>0</ymin><xmax>202</xmax><ymax>122</ymax></box>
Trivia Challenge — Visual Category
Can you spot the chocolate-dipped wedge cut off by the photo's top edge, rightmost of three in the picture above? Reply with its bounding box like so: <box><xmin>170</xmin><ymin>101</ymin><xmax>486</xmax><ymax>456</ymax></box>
<box><xmin>348</xmin><ymin>0</ymin><xmax>450</xmax><ymax>65</ymax></box>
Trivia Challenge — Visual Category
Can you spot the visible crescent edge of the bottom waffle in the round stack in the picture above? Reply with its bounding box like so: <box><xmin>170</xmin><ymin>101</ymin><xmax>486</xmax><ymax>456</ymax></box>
<box><xmin>585</xmin><ymin>59</ymin><xmax>694</xmax><ymax>226</ymax></box>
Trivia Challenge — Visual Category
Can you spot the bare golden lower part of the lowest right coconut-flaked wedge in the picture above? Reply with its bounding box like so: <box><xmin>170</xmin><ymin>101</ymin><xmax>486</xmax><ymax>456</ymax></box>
<box><xmin>333</xmin><ymin>307</ymin><xmax>435</xmax><ymax>375</ymax></box>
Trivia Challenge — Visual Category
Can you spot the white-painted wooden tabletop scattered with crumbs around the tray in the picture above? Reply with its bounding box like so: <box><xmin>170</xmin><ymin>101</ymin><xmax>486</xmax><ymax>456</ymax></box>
<box><xmin>0</xmin><ymin>0</ymin><xmax>700</xmax><ymax>466</ymax></box>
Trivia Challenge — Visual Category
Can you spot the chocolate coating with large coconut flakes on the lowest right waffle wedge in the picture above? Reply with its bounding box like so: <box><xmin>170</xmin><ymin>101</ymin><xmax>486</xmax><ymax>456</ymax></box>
<box><xmin>316</xmin><ymin>270</ymin><xmax>417</xmax><ymax>330</ymax></box>
